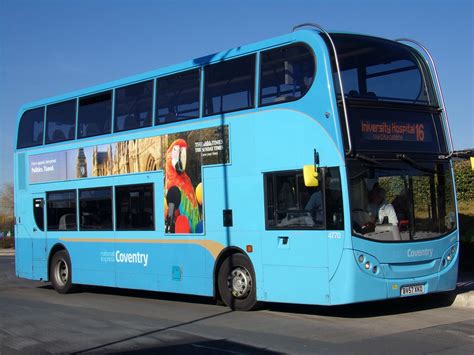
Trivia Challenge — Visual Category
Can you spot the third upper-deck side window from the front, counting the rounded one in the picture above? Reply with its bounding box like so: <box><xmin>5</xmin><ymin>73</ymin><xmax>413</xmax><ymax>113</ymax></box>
<box><xmin>155</xmin><ymin>69</ymin><xmax>201</xmax><ymax>124</ymax></box>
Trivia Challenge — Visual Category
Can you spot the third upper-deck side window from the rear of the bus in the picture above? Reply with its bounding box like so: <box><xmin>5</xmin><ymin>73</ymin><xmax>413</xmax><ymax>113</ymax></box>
<box><xmin>77</xmin><ymin>91</ymin><xmax>112</xmax><ymax>138</ymax></box>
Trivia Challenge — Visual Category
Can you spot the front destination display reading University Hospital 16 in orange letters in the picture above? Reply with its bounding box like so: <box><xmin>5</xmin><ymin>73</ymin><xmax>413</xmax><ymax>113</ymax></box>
<box><xmin>349</xmin><ymin>108</ymin><xmax>446</xmax><ymax>152</ymax></box>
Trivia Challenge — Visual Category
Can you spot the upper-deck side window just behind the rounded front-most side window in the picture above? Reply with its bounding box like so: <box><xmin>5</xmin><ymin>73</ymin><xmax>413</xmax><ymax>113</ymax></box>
<box><xmin>204</xmin><ymin>55</ymin><xmax>255</xmax><ymax>115</ymax></box>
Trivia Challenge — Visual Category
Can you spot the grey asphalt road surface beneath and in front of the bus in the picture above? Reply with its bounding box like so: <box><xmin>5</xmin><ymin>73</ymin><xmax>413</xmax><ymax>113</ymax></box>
<box><xmin>0</xmin><ymin>257</ymin><xmax>474</xmax><ymax>355</ymax></box>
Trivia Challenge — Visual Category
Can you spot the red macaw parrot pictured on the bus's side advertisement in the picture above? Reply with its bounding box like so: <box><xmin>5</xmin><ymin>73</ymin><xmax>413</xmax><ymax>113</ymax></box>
<box><xmin>165</xmin><ymin>139</ymin><xmax>200</xmax><ymax>233</ymax></box>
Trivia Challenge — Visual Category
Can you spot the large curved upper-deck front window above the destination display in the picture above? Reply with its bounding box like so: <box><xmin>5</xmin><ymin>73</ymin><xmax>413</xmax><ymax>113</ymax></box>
<box><xmin>332</xmin><ymin>34</ymin><xmax>435</xmax><ymax>105</ymax></box>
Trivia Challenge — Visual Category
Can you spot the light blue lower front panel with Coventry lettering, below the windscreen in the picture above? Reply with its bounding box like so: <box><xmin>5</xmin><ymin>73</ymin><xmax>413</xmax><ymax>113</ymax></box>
<box><xmin>330</xmin><ymin>231</ymin><xmax>459</xmax><ymax>305</ymax></box>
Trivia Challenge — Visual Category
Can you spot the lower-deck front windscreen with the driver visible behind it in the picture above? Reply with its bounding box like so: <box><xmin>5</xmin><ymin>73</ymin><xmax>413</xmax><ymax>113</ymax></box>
<box><xmin>348</xmin><ymin>159</ymin><xmax>456</xmax><ymax>242</ymax></box>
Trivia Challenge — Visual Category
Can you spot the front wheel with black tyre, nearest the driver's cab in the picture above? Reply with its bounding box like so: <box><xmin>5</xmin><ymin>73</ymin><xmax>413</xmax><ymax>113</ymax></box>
<box><xmin>217</xmin><ymin>254</ymin><xmax>257</xmax><ymax>311</ymax></box>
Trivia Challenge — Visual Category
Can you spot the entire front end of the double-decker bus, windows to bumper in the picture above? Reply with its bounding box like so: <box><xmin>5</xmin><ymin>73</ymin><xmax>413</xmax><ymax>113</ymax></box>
<box><xmin>327</xmin><ymin>34</ymin><xmax>459</xmax><ymax>304</ymax></box>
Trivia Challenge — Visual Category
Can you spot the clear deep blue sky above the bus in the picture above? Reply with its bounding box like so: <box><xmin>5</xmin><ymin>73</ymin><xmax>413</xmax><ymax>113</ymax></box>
<box><xmin>0</xmin><ymin>0</ymin><xmax>474</xmax><ymax>185</ymax></box>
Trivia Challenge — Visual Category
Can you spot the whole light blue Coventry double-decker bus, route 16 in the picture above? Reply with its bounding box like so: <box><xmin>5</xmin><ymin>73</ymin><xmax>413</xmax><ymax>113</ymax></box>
<box><xmin>14</xmin><ymin>24</ymin><xmax>459</xmax><ymax>310</ymax></box>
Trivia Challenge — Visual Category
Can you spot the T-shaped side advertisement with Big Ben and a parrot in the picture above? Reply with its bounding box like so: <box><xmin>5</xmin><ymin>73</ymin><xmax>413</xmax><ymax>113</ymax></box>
<box><xmin>29</xmin><ymin>126</ymin><xmax>229</xmax><ymax>234</ymax></box>
